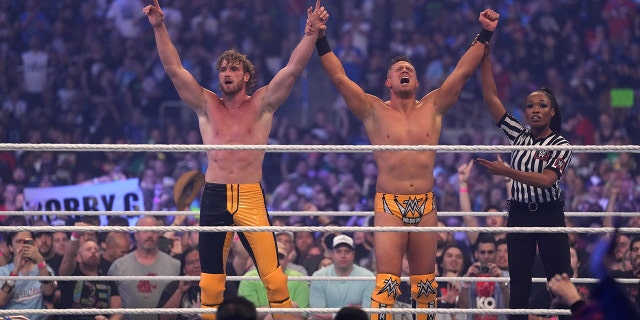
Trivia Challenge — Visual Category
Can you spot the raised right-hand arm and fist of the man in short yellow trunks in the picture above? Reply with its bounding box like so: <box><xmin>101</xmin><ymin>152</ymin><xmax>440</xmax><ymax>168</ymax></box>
<box><xmin>432</xmin><ymin>9</ymin><xmax>499</xmax><ymax>114</ymax></box>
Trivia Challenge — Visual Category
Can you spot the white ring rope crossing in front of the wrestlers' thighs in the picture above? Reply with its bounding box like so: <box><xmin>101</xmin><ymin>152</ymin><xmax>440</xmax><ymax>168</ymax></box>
<box><xmin>0</xmin><ymin>226</ymin><xmax>640</xmax><ymax>233</ymax></box>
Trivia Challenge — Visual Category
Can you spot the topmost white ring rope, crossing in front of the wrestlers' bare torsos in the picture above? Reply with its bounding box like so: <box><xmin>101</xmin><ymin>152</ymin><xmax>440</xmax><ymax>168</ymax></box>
<box><xmin>0</xmin><ymin>143</ymin><xmax>640</xmax><ymax>153</ymax></box>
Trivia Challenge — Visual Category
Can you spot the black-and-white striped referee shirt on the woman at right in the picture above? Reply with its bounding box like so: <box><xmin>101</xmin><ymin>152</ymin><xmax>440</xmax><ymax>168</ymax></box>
<box><xmin>497</xmin><ymin>113</ymin><xmax>571</xmax><ymax>203</ymax></box>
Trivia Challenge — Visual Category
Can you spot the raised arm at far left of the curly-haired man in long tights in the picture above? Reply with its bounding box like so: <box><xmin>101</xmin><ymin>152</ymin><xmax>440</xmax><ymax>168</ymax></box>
<box><xmin>144</xmin><ymin>0</ymin><xmax>207</xmax><ymax>111</ymax></box>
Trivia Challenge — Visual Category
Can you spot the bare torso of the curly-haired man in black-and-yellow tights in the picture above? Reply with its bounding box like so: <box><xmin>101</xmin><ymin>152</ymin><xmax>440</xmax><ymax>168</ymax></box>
<box><xmin>198</xmin><ymin>94</ymin><xmax>273</xmax><ymax>184</ymax></box>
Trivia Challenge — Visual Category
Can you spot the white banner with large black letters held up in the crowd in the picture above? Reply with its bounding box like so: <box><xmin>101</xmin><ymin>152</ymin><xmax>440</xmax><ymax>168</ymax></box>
<box><xmin>24</xmin><ymin>178</ymin><xmax>144</xmax><ymax>211</ymax></box>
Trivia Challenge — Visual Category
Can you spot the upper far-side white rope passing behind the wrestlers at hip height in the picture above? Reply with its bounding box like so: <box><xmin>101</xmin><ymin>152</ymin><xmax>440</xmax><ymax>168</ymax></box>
<box><xmin>2</xmin><ymin>211</ymin><xmax>640</xmax><ymax>217</ymax></box>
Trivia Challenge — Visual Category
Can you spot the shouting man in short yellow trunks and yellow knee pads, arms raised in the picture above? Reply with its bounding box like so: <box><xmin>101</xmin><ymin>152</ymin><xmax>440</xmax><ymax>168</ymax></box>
<box><xmin>316</xmin><ymin>10</ymin><xmax>498</xmax><ymax>319</ymax></box>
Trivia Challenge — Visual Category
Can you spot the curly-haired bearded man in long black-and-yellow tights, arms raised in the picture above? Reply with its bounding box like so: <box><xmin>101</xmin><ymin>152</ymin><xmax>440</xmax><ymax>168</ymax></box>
<box><xmin>144</xmin><ymin>0</ymin><xmax>329</xmax><ymax>319</ymax></box>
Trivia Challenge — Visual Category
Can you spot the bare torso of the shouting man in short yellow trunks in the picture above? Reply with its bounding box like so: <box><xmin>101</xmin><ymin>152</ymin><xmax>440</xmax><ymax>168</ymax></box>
<box><xmin>364</xmin><ymin>96</ymin><xmax>442</xmax><ymax>194</ymax></box>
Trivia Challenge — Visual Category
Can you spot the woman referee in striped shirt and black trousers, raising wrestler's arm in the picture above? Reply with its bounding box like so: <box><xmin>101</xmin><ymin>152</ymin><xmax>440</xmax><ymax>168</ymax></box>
<box><xmin>476</xmin><ymin>50</ymin><xmax>571</xmax><ymax>319</ymax></box>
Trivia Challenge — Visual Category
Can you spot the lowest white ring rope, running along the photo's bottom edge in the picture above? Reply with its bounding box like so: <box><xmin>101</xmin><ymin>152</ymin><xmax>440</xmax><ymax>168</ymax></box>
<box><xmin>0</xmin><ymin>308</ymin><xmax>571</xmax><ymax>316</ymax></box>
